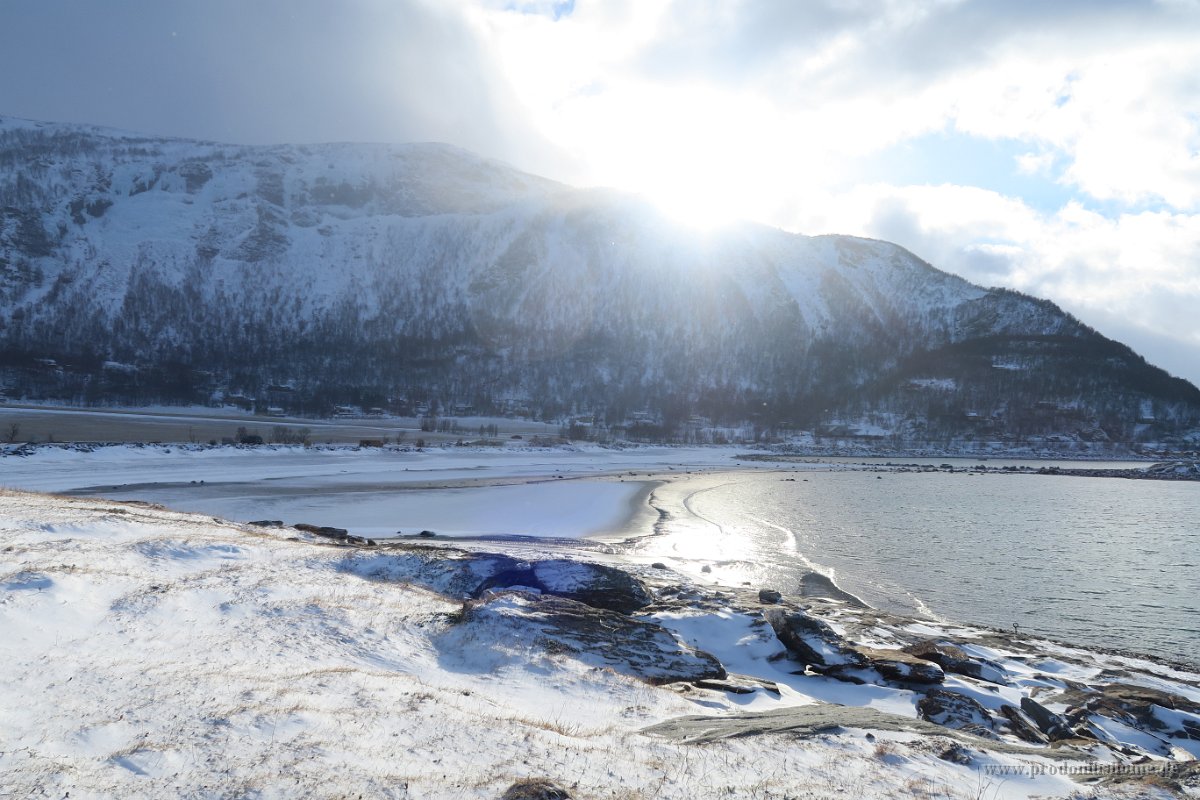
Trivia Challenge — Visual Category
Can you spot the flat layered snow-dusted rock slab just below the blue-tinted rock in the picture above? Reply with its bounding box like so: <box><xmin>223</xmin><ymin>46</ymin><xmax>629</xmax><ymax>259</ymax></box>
<box><xmin>448</xmin><ymin>591</ymin><xmax>726</xmax><ymax>685</ymax></box>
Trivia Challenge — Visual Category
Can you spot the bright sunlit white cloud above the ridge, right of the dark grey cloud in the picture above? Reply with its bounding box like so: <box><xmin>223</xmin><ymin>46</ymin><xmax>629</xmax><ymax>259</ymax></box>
<box><xmin>458</xmin><ymin>0</ymin><xmax>1200</xmax><ymax>383</ymax></box>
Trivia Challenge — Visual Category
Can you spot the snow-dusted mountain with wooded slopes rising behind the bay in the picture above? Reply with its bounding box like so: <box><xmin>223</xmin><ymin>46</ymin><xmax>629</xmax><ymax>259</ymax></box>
<box><xmin>0</xmin><ymin>120</ymin><xmax>1200</xmax><ymax>437</ymax></box>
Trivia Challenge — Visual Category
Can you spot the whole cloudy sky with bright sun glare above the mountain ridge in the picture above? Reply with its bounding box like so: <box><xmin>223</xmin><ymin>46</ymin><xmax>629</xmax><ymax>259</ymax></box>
<box><xmin>7</xmin><ymin>0</ymin><xmax>1200</xmax><ymax>384</ymax></box>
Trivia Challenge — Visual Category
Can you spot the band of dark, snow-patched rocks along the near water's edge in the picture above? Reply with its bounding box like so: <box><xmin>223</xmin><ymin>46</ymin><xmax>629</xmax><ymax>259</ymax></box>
<box><xmin>331</xmin><ymin>525</ymin><xmax>1200</xmax><ymax>759</ymax></box>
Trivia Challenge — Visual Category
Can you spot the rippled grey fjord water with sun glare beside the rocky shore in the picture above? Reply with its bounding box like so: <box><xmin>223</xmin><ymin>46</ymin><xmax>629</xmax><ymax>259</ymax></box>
<box><xmin>664</xmin><ymin>471</ymin><xmax>1200</xmax><ymax>664</ymax></box>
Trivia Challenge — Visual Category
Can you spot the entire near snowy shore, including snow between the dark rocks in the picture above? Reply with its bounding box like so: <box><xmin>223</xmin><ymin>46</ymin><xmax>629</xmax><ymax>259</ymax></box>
<box><xmin>0</xmin><ymin>491</ymin><xmax>1200</xmax><ymax>798</ymax></box>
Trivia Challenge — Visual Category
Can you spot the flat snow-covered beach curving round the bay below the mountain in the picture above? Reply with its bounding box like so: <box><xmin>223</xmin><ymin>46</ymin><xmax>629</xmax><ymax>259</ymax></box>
<box><xmin>0</xmin><ymin>443</ymin><xmax>1166</xmax><ymax>539</ymax></box>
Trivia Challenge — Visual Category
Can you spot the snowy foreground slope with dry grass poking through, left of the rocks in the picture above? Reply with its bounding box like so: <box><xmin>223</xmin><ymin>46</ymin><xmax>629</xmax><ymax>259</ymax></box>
<box><xmin>0</xmin><ymin>492</ymin><xmax>1132</xmax><ymax>798</ymax></box>
